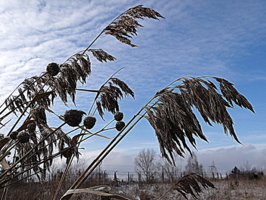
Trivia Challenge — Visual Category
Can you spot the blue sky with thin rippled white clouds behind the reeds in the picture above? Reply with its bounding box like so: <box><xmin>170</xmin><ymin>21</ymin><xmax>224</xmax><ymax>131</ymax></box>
<box><xmin>0</xmin><ymin>0</ymin><xmax>266</xmax><ymax>175</ymax></box>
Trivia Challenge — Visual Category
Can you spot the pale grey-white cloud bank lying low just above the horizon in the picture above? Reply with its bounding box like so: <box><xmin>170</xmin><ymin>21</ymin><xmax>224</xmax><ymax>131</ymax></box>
<box><xmin>70</xmin><ymin>144</ymin><xmax>266</xmax><ymax>175</ymax></box>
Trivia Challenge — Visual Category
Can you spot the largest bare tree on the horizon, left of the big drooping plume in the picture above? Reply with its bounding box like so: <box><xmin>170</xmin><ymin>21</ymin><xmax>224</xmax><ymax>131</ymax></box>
<box><xmin>135</xmin><ymin>149</ymin><xmax>156</xmax><ymax>183</ymax></box>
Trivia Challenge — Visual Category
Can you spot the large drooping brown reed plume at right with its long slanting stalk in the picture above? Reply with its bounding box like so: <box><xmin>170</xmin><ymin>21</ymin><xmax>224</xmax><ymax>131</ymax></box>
<box><xmin>62</xmin><ymin>77</ymin><xmax>254</xmax><ymax>200</ymax></box>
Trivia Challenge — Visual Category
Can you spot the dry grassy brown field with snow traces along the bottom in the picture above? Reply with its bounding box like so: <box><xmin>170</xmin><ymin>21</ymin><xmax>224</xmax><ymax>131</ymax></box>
<box><xmin>0</xmin><ymin>178</ymin><xmax>266</xmax><ymax>200</ymax></box>
